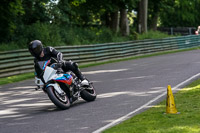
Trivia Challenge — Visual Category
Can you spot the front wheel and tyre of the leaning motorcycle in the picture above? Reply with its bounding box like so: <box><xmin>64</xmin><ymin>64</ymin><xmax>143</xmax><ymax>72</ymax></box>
<box><xmin>46</xmin><ymin>86</ymin><xmax>70</xmax><ymax>110</ymax></box>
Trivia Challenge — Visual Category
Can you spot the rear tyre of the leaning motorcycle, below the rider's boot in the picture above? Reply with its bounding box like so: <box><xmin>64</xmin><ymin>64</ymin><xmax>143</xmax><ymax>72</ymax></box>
<box><xmin>80</xmin><ymin>83</ymin><xmax>97</xmax><ymax>102</ymax></box>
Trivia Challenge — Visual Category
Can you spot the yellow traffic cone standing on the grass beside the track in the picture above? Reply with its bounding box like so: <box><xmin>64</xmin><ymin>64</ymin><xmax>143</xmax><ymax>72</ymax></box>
<box><xmin>166</xmin><ymin>85</ymin><xmax>179</xmax><ymax>114</ymax></box>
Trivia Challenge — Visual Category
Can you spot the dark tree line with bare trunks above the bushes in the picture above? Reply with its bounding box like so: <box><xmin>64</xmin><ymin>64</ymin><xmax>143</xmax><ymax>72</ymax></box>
<box><xmin>0</xmin><ymin>0</ymin><xmax>200</xmax><ymax>46</ymax></box>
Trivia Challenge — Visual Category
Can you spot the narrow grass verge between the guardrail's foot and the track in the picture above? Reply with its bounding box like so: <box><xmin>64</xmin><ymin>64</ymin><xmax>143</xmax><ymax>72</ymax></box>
<box><xmin>0</xmin><ymin>47</ymin><xmax>199</xmax><ymax>85</ymax></box>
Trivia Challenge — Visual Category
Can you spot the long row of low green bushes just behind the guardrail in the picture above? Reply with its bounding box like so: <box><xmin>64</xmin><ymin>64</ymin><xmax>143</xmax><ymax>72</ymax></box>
<box><xmin>0</xmin><ymin>22</ymin><xmax>173</xmax><ymax>51</ymax></box>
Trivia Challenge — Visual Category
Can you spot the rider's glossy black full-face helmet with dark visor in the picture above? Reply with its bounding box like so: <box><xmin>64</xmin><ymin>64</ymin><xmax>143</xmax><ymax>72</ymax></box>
<box><xmin>28</xmin><ymin>40</ymin><xmax>43</xmax><ymax>57</ymax></box>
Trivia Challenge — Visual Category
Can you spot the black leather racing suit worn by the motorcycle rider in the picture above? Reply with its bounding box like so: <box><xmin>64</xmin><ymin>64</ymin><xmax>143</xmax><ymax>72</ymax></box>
<box><xmin>34</xmin><ymin>47</ymin><xmax>84</xmax><ymax>80</ymax></box>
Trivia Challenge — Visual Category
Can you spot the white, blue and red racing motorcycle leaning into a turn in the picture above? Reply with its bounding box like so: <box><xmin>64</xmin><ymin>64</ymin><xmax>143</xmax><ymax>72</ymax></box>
<box><xmin>35</xmin><ymin>58</ymin><xmax>96</xmax><ymax>109</ymax></box>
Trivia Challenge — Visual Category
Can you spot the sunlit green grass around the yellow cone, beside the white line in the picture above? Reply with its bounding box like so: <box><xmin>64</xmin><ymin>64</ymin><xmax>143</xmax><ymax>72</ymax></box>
<box><xmin>103</xmin><ymin>79</ymin><xmax>200</xmax><ymax>133</ymax></box>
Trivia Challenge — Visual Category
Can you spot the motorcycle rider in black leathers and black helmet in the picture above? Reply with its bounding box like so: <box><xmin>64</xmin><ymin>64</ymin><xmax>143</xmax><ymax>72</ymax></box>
<box><xmin>28</xmin><ymin>40</ymin><xmax>89</xmax><ymax>86</ymax></box>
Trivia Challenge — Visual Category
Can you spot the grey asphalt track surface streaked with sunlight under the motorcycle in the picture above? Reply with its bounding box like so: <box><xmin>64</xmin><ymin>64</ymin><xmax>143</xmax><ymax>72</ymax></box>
<box><xmin>0</xmin><ymin>50</ymin><xmax>200</xmax><ymax>133</ymax></box>
